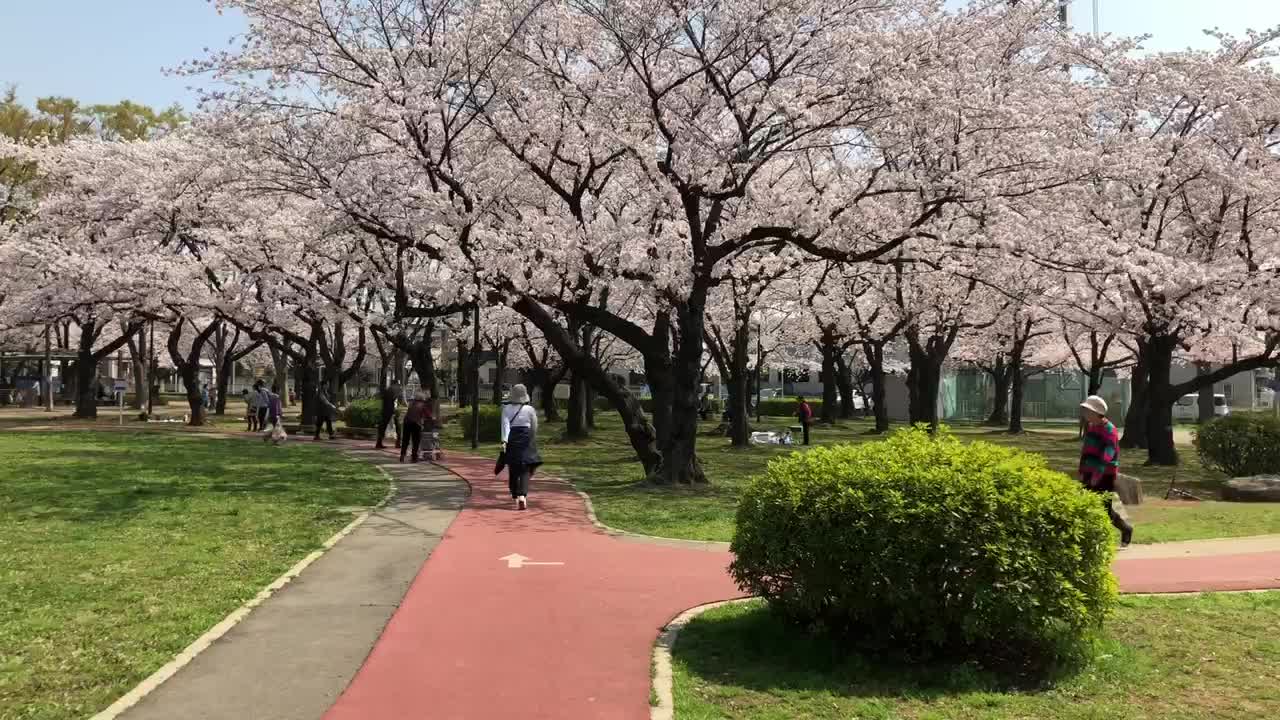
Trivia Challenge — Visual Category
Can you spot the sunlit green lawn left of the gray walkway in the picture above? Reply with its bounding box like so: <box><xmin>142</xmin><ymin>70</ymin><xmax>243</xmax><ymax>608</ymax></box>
<box><xmin>0</xmin><ymin>432</ymin><xmax>388</xmax><ymax>720</ymax></box>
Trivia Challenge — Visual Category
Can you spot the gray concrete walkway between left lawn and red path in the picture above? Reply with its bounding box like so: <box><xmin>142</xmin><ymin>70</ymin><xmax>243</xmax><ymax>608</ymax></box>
<box><xmin>120</xmin><ymin>448</ymin><xmax>467</xmax><ymax>720</ymax></box>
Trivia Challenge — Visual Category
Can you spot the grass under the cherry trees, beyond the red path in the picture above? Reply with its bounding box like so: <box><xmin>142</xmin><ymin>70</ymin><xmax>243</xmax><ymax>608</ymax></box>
<box><xmin>448</xmin><ymin>413</ymin><xmax>1280</xmax><ymax>543</ymax></box>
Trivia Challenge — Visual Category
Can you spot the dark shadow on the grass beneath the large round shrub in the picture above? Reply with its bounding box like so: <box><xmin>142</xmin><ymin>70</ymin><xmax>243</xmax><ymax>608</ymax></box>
<box><xmin>675</xmin><ymin>602</ymin><xmax>1095</xmax><ymax>701</ymax></box>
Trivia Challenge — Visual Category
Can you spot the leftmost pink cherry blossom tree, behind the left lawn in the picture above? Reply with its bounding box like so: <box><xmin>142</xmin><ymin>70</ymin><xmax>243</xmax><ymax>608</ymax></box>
<box><xmin>4</xmin><ymin>138</ymin><xmax>217</xmax><ymax>418</ymax></box>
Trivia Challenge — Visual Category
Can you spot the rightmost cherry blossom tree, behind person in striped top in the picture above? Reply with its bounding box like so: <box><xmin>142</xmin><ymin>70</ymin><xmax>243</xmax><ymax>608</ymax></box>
<box><xmin>1052</xmin><ymin>31</ymin><xmax>1280</xmax><ymax>464</ymax></box>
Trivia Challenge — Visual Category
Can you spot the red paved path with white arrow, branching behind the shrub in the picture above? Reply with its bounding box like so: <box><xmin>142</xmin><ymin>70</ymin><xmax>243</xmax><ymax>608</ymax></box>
<box><xmin>325</xmin><ymin>445</ymin><xmax>1280</xmax><ymax>720</ymax></box>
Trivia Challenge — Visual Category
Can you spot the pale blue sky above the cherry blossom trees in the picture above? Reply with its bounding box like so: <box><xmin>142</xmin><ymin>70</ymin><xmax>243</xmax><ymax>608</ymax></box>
<box><xmin>0</xmin><ymin>0</ymin><xmax>1280</xmax><ymax>106</ymax></box>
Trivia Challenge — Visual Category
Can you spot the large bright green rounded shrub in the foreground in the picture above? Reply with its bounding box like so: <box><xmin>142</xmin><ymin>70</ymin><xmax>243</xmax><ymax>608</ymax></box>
<box><xmin>731</xmin><ymin>428</ymin><xmax>1116</xmax><ymax>662</ymax></box>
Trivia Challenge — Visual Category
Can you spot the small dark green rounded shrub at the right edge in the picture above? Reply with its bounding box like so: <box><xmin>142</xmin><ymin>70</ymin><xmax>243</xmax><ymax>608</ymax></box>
<box><xmin>1194</xmin><ymin>413</ymin><xmax>1280</xmax><ymax>478</ymax></box>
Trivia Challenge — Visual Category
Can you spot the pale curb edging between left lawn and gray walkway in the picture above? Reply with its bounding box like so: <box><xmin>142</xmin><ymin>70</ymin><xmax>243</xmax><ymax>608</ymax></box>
<box><xmin>90</xmin><ymin>451</ymin><xmax>397</xmax><ymax>720</ymax></box>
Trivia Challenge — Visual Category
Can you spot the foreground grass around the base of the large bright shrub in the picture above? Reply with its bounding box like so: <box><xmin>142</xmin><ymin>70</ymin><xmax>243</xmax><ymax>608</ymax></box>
<box><xmin>675</xmin><ymin>592</ymin><xmax>1280</xmax><ymax>720</ymax></box>
